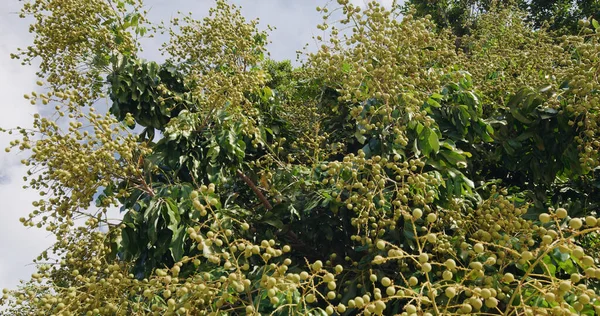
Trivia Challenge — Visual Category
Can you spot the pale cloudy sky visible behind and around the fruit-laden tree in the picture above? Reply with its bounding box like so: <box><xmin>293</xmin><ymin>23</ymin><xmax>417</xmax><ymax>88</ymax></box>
<box><xmin>0</xmin><ymin>0</ymin><xmax>392</xmax><ymax>296</ymax></box>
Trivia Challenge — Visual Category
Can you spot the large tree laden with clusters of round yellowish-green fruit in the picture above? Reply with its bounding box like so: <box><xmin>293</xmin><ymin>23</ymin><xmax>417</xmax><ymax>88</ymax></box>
<box><xmin>0</xmin><ymin>0</ymin><xmax>600</xmax><ymax>315</ymax></box>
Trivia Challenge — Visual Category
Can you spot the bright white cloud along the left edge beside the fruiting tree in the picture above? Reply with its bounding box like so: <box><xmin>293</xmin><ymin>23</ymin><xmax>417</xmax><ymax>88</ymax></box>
<box><xmin>0</xmin><ymin>1</ymin><xmax>51</xmax><ymax>288</ymax></box>
